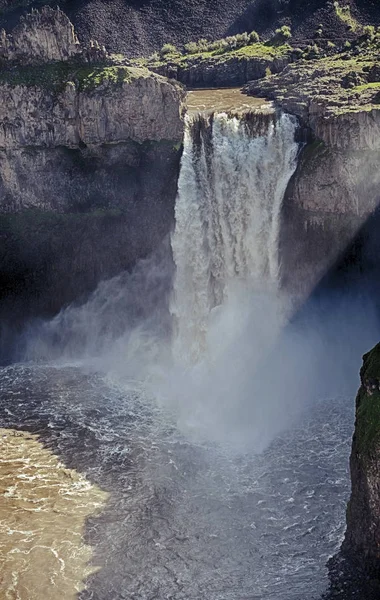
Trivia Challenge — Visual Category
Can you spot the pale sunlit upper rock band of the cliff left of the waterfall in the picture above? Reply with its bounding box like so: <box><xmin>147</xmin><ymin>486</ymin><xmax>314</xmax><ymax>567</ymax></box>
<box><xmin>0</xmin><ymin>67</ymin><xmax>184</xmax><ymax>155</ymax></box>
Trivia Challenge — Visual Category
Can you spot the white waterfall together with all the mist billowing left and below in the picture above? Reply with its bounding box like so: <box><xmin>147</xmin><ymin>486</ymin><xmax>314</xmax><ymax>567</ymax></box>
<box><xmin>26</xmin><ymin>106</ymin><xmax>354</xmax><ymax>450</ymax></box>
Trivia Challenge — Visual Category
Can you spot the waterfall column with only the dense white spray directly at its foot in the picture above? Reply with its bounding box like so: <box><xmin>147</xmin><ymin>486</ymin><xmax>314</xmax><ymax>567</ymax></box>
<box><xmin>160</xmin><ymin>112</ymin><xmax>298</xmax><ymax>449</ymax></box>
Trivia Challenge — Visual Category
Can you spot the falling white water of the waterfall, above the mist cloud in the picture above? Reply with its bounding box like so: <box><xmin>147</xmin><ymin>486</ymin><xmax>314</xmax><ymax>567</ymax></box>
<box><xmin>171</xmin><ymin>113</ymin><xmax>298</xmax><ymax>363</ymax></box>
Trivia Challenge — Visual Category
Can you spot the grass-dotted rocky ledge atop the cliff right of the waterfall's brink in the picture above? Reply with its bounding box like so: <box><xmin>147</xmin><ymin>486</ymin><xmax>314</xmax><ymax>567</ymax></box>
<box><xmin>246</xmin><ymin>55</ymin><xmax>380</xmax><ymax>151</ymax></box>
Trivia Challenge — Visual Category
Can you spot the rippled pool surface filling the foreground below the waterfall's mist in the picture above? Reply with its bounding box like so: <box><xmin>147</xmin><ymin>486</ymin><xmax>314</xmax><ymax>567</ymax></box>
<box><xmin>0</xmin><ymin>366</ymin><xmax>354</xmax><ymax>600</ymax></box>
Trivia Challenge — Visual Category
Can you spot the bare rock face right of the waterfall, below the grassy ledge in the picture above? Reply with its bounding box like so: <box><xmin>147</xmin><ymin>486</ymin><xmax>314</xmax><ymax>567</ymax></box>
<box><xmin>280</xmin><ymin>140</ymin><xmax>380</xmax><ymax>303</ymax></box>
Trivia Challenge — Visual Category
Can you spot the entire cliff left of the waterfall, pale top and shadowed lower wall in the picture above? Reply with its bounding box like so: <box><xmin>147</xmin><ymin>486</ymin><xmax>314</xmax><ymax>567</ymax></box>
<box><xmin>0</xmin><ymin>9</ymin><xmax>185</xmax><ymax>360</ymax></box>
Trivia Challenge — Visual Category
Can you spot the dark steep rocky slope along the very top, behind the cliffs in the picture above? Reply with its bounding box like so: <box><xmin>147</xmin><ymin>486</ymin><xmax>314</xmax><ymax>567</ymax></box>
<box><xmin>0</xmin><ymin>0</ymin><xmax>380</xmax><ymax>56</ymax></box>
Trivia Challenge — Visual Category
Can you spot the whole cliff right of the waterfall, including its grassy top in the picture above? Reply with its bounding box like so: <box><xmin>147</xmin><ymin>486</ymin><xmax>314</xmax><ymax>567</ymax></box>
<box><xmin>246</xmin><ymin>55</ymin><xmax>380</xmax><ymax>302</ymax></box>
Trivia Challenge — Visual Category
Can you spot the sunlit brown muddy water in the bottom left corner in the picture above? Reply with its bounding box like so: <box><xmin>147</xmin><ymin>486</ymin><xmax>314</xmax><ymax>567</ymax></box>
<box><xmin>0</xmin><ymin>429</ymin><xmax>107</xmax><ymax>600</ymax></box>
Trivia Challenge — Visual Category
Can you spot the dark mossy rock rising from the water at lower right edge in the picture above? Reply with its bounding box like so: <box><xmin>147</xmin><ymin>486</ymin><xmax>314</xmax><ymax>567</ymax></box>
<box><xmin>323</xmin><ymin>344</ymin><xmax>380</xmax><ymax>600</ymax></box>
